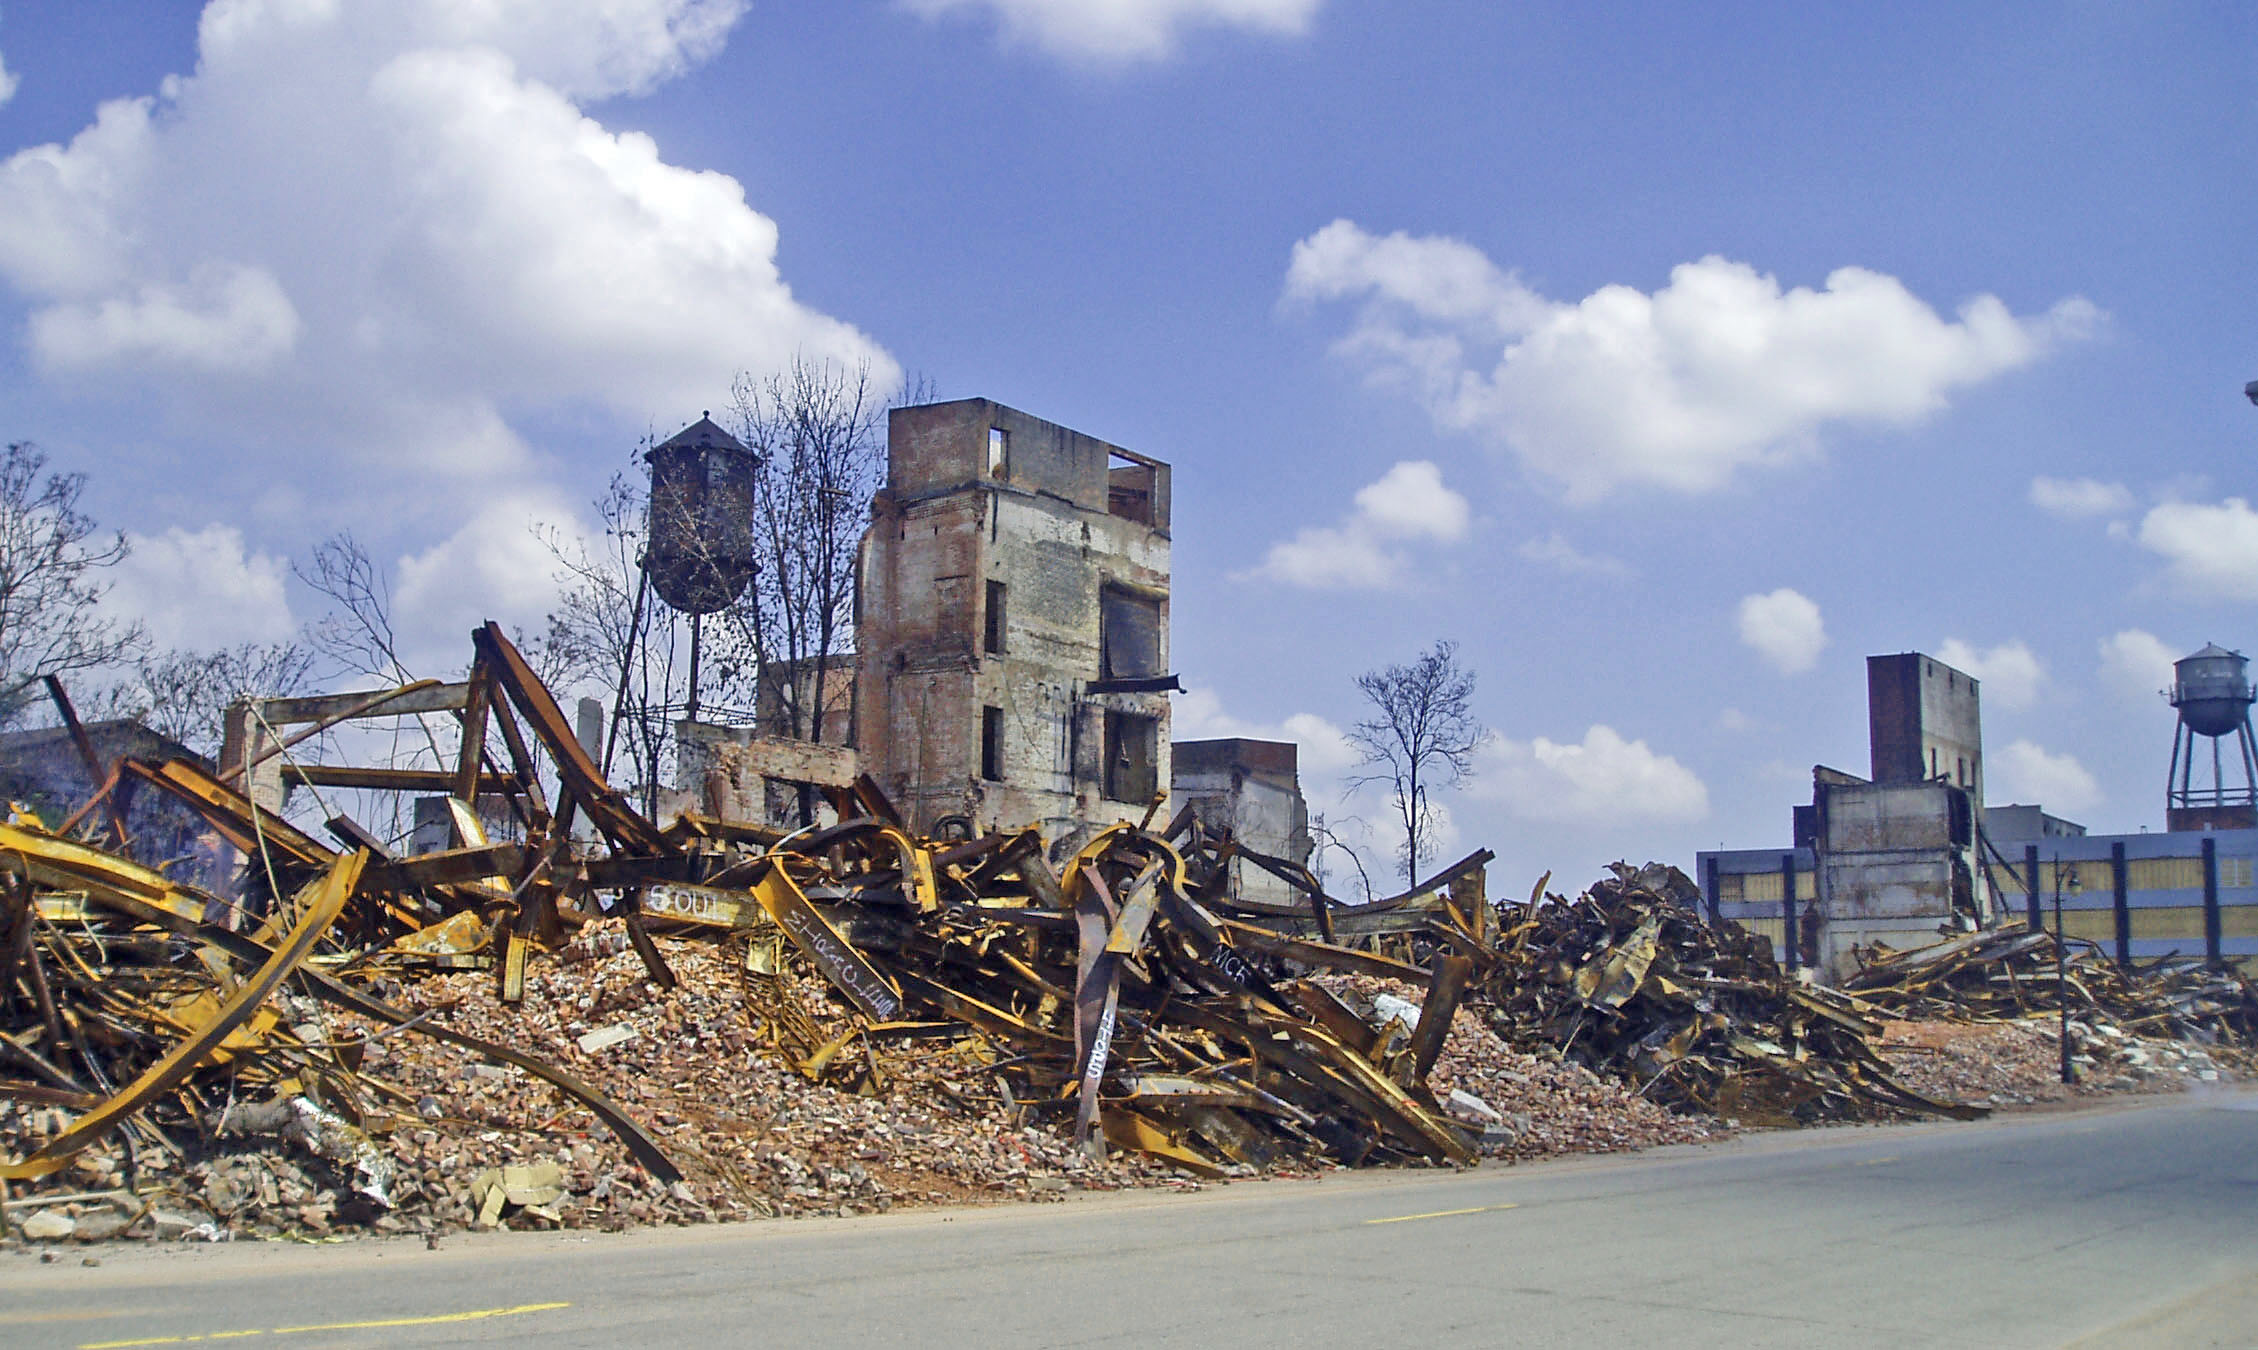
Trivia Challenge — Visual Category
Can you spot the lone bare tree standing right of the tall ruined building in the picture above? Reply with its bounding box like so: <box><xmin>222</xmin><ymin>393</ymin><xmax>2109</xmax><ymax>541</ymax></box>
<box><xmin>1348</xmin><ymin>639</ymin><xmax>1486</xmax><ymax>885</ymax></box>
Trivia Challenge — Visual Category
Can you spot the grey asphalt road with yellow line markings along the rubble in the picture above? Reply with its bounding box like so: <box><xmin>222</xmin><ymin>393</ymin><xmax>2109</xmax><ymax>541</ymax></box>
<box><xmin>0</xmin><ymin>1093</ymin><xmax>2258</xmax><ymax>1350</ymax></box>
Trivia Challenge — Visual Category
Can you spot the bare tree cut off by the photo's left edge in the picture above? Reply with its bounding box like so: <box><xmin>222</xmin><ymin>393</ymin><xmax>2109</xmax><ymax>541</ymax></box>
<box><xmin>0</xmin><ymin>440</ymin><xmax>147</xmax><ymax>727</ymax></box>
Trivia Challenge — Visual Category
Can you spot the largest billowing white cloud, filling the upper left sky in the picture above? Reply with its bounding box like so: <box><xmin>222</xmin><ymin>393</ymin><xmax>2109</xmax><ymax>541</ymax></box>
<box><xmin>0</xmin><ymin>0</ymin><xmax>899</xmax><ymax>505</ymax></box>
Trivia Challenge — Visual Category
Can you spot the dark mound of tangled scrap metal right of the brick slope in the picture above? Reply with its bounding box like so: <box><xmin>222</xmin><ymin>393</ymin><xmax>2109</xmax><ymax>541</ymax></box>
<box><xmin>1481</xmin><ymin>862</ymin><xmax>1983</xmax><ymax>1124</ymax></box>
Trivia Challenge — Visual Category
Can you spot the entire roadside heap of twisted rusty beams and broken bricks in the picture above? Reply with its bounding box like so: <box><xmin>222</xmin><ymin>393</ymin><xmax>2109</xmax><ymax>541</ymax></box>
<box><xmin>13</xmin><ymin>625</ymin><xmax>2251</xmax><ymax>1239</ymax></box>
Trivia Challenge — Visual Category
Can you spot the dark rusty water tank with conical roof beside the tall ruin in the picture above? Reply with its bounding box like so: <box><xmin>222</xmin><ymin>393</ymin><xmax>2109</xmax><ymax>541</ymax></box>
<box><xmin>644</xmin><ymin>415</ymin><xmax>759</xmax><ymax>614</ymax></box>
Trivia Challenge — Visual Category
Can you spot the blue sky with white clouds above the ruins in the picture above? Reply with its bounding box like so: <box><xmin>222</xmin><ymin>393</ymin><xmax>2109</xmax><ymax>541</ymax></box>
<box><xmin>0</xmin><ymin>0</ymin><xmax>2258</xmax><ymax>889</ymax></box>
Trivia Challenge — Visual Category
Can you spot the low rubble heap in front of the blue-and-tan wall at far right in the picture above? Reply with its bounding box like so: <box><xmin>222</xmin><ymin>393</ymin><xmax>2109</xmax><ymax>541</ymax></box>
<box><xmin>1843</xmin><ymin>923</ymin><xmax>2258</xmax><ymax>1052</ymax></box>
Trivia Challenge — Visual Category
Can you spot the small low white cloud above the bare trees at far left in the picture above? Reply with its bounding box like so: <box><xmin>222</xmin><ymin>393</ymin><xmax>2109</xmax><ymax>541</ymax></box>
<box><xmin>104</xmin><ymin>524</ymin><xmax>296</xmax><ymax>650</ymax></box>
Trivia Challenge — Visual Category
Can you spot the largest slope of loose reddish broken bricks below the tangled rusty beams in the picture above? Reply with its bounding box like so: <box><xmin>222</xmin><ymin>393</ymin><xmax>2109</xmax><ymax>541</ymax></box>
<box><xmin>359</xmin><ymin>937</ymin><xmax>1179</xmax><ymax>1228</ymax></box>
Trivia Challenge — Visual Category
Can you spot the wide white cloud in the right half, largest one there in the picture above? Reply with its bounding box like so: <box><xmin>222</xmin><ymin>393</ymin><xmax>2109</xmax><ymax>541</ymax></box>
<box><xmin>1285</xmin><ymin>219</ymin><xmax>2100</xmax><ymax>501</ymax></box>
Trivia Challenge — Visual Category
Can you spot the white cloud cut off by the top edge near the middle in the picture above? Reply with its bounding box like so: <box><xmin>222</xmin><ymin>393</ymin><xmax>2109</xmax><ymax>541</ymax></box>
<box><xmin>903</xmin><ymin>0</ymin><xmax>1323</xmax><ymax>63</ymax></box>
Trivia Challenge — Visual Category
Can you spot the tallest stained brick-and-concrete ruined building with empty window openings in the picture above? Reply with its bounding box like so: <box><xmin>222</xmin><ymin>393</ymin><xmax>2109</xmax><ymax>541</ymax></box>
<box><xmin>856</xmin><ymin>400</ymin><xmax>1174</xmax><ymax>842</ymax></box>
